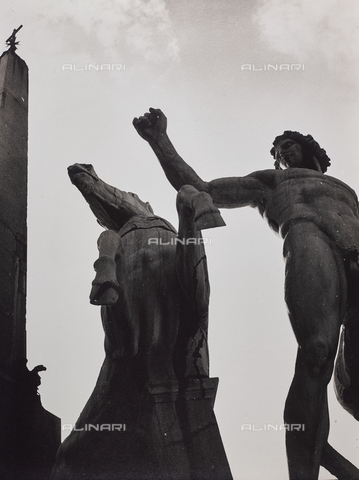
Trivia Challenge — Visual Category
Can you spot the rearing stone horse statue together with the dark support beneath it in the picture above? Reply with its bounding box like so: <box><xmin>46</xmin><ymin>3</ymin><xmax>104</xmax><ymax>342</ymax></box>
<box><xmin>51</xmin><ymin>164</ymin><xmax>232</xmax><ymax>480</ymax></box>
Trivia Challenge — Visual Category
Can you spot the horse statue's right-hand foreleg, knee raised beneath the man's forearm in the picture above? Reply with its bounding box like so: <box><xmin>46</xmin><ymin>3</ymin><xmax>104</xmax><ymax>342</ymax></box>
<box><xmin>176</xmin><ymin>185</ymin><xmax>224</xmax><ymax>378</ymax></box>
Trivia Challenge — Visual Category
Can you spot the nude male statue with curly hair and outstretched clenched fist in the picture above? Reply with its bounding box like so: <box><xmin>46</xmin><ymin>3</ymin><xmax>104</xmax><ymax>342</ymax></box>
<box><xmin>133</xmin><ymin>109</ymin><xmax>359</xmax><ymax>480</ymax></box>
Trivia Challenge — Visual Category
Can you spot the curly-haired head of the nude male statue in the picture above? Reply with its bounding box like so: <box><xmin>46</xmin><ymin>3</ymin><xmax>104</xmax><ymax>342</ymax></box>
<box><xmin>270</xmin><ymin>130</ymin><xmax>330</xmax><ymax>173</ymax></box>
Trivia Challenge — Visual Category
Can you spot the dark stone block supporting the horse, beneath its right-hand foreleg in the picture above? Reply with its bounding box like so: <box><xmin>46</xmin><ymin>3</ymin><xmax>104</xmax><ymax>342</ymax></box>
<box><xmin>146</xmin><ymin>378</ymin><xmax>232</xmax><ymax>480</ymax></box>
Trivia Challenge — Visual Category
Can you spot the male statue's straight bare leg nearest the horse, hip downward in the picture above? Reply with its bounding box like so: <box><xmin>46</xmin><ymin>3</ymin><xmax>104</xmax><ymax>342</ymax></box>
<box><xmin>284</xmin><ymin>223</ymin><xmax>347</xmax><ymax>480</ymax></box>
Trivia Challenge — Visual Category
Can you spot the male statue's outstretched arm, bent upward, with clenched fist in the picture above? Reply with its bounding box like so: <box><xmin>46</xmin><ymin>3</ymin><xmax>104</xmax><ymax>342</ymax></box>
<box><xmin>133</xmin><ymin>108</ymin><xmax>275</xmax><ymax>208</ymax></box>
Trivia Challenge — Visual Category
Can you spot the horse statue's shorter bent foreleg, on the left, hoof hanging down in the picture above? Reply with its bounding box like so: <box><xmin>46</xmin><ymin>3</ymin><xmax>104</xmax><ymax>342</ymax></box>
<box><xmin>90</xmin><ymin>230</ymin><xmax>121</xmax><ymax>306</ymax></box>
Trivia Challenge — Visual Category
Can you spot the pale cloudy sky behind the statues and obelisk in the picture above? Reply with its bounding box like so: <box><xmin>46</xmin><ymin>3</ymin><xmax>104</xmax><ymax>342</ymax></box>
<box><xmin>0</xmin><ymin>0</ymin><xmax>359</xmax><ymax>480</ymax></box>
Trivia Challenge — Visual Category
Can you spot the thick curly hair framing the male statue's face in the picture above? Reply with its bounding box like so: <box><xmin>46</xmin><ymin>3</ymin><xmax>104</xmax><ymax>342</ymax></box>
<box><xmin>270</xmin><ymin>130</ymin><xmax>330</xmax><ymax>173</ymax></box>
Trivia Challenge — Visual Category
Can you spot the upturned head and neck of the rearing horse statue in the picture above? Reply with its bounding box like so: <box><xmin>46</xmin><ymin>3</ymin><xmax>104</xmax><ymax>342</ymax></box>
<box><xmin>68</xmin><ymin>163</ymin><xmax>154</xmax><ymax>232</ymax></box>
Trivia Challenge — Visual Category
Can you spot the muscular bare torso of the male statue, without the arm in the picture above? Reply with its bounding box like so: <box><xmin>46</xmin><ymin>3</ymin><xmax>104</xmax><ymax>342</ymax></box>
<box><xmin>262</xmin><ymin>168</ymin><xmax>359</xmax><ymax>252</ymax></box>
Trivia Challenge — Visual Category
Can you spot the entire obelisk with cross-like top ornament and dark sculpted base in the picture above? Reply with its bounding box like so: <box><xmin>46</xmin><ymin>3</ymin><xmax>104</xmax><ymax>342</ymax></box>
<box><xmin>0</xmin><ymin>27</ymin><xmax>60</xmax><ymax>480</ymax></box>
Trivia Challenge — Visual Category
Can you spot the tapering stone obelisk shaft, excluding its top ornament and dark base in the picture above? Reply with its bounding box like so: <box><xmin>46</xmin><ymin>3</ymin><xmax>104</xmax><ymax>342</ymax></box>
<box><xmin>0</xmin><ymin>26</ymin><xmax>28</xmax><ymax>373</ymax></box>
